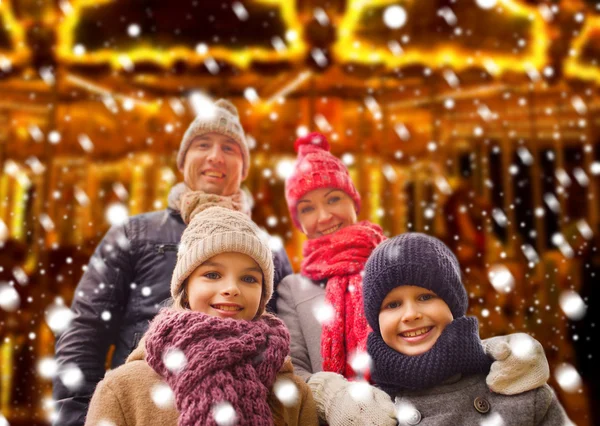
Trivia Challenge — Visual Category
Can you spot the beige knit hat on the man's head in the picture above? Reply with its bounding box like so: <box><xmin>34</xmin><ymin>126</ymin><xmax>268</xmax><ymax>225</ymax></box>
<box><xmin>177</xmin><ymin>99</ymin><xmax>250</xmax><ymax>179</ymax></box>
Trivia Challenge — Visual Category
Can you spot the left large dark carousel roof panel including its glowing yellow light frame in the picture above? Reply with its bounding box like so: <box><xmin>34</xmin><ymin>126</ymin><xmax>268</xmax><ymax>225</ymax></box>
<box><xmin>57</xmin><ymin>0</ymin><xmax>306</xmax><ymax>69</ymax></box>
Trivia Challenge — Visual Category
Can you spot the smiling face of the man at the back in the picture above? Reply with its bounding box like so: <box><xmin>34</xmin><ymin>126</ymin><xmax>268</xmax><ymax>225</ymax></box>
<box><xmin>183</xmin><ymin>132</ymin><xmax>243</xmax><ymax>196</ymax></box>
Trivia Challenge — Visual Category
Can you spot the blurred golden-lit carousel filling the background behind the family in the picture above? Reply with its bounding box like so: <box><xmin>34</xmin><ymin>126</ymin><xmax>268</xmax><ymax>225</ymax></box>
<box><xmin>0</xmin><ymin>0</ymin><xmax>600</xmax><ymax>426</ymax></box>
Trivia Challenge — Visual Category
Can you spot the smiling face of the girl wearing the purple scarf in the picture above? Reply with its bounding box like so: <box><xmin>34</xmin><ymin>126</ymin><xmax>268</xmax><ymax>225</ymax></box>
<box><xmin>186</xmin><ymin>253</ymin><xmax>263</xmax><ymax>321</ymax></box>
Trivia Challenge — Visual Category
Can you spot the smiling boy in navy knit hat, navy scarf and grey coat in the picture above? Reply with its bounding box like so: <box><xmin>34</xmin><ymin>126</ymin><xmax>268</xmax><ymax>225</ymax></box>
<box><xmin>363</xmin><ymin>233</ymin><xmax>572</xmax><ymax>426</ymax></box>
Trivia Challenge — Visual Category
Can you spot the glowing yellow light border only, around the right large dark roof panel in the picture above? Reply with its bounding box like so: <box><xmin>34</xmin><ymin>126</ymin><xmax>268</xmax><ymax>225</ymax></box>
<box><xmin>333</xmin><ymin>0</ymin><xmax>550</xmax><ymax>74</ymax></box>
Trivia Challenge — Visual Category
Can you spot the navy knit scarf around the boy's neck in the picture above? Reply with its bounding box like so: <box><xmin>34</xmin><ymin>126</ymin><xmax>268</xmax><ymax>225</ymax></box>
<box><xmin>367</xmin><ymin>316</ymin><xmax>492</xmax><ymax>395</ymax></box>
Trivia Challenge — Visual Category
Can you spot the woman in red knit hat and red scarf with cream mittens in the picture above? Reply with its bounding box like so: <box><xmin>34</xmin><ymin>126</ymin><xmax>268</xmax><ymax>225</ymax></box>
<box><xmin>277</xmin><ymin>133</ymin><xmax>549</xmax><ymax>426</ymax></box>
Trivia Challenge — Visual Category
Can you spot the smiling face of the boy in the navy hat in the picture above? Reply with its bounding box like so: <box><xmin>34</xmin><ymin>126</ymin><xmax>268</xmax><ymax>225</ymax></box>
<box><xmin>379</xmin><ymin>285</ymin><xmax>454</xmax><ymax>356</ymax></box>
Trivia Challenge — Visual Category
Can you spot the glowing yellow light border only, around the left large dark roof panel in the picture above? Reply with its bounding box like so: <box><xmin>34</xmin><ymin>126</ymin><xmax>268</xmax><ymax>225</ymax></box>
<box><xmin>57</xmin><ymin>0</ymin><xmax>307</xmax><ymax>69</ymax></box>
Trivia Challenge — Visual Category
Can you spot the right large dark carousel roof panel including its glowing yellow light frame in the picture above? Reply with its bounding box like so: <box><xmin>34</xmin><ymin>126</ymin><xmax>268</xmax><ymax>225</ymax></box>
<box><xmin>333</xmin><ymin>0</ymin><xmax>550</xmax><ymax>75</ymax></box>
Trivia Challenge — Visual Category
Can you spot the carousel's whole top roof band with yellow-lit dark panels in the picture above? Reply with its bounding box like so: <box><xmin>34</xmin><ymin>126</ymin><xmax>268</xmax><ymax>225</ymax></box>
<box><xmin>0</xmin><ymin>0</ymin><xmax>600</xmax><ymax>87</ymax></box>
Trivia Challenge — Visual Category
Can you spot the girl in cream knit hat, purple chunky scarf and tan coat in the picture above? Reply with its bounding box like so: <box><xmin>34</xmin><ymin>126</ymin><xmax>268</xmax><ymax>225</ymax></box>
<box><xmin>86</xmin><ymin>198</ymin><xmax>317</xmax><ymax>425</ymax></box>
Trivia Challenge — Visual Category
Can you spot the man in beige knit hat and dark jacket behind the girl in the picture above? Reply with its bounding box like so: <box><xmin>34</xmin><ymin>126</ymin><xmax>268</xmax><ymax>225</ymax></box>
<box><xmin>53</xmin><ymin>99</ymin><xmax>292</xmax><ymax>425</ymax></box>
